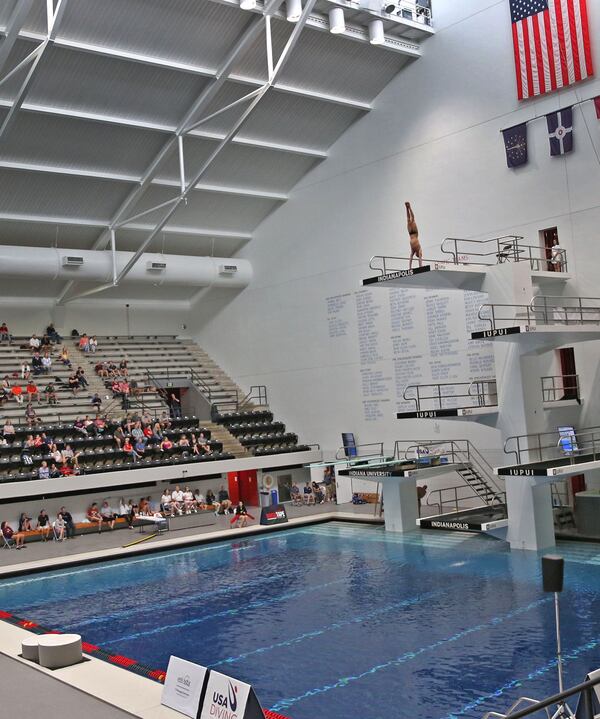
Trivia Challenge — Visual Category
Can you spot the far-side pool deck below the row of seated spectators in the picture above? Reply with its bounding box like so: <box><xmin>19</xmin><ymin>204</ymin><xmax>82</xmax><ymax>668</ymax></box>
<box><xmin>0</xmin><ymin>503</ymin><xmax>390</xmax><ymax>580</ymax></box>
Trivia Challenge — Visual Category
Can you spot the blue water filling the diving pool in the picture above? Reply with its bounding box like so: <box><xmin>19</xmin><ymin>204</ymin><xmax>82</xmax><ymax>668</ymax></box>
<box><xmin>0</xmin><ymin>523</ymin><xmax>600</xmax><ymax>719</ymax></box>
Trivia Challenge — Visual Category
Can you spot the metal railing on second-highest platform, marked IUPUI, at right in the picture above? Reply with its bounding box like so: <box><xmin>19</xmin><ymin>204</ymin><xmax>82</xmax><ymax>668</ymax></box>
<box><xmin>477</xmin><ymin>295</ymin><xmax>600</xmax><ymax>330</ymax></box>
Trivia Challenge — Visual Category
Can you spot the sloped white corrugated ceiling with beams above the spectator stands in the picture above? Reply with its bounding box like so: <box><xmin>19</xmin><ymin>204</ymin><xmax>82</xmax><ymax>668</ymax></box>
<box><xmin>0</xmin><ymin>0</ymin><xmax>431</xmax><ymax>299</ymax></box>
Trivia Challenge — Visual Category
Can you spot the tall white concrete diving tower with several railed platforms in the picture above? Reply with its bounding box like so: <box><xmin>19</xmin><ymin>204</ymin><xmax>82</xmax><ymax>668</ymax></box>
<box><xmin>360</xmin><ymin>235</ymin><xmax>600</xmax><ymax>550</ymax></box>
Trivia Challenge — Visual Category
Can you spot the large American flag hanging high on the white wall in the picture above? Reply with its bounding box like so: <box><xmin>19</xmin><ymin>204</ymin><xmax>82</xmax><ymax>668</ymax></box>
<box><xmin>510</xmin><ymin>0</ymin><xmax>594</xmax><ymax>100</ymax></box>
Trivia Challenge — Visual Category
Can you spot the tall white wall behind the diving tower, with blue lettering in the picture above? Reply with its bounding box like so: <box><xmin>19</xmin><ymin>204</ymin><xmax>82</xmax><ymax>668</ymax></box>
<box><xmin>191</xmin><ymin>0</ymin><xmax>600</xmax><ymax>478</ymax></box>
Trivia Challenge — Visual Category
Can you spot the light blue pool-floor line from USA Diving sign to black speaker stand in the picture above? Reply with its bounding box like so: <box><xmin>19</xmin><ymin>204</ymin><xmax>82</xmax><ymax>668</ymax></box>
<box><xmin>271</xmin><ymin>597</ymin><xmax>553</xmax><ymax>711</ymax></box>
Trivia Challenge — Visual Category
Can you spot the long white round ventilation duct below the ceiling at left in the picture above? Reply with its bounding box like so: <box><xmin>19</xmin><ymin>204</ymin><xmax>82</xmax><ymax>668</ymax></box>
<box><xmin>0</xmin><ymin>245</ymin><xmax>252</xmax><ymax>288</ymax></box>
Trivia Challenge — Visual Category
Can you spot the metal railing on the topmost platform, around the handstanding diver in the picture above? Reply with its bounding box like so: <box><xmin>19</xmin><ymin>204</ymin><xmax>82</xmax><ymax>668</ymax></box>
<box><xmin>369</xmin><ymin>235</ymin><xmax>568</xmax><ymax>275</ymax></box>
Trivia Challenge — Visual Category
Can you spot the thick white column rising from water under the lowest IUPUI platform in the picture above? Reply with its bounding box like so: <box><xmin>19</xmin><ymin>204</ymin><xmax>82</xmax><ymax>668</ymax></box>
<box><xmin>506</xmin><ymin>477</ymin><xmax>556</xmax><ymax>551</ymax></box>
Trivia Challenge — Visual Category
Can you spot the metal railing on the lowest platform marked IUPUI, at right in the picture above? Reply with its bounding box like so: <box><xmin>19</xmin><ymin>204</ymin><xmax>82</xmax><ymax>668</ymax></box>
<box><xmin>504</xmin><ymin>427</ymin><xmax>600</xmax><ymax>464</ymax></box>
